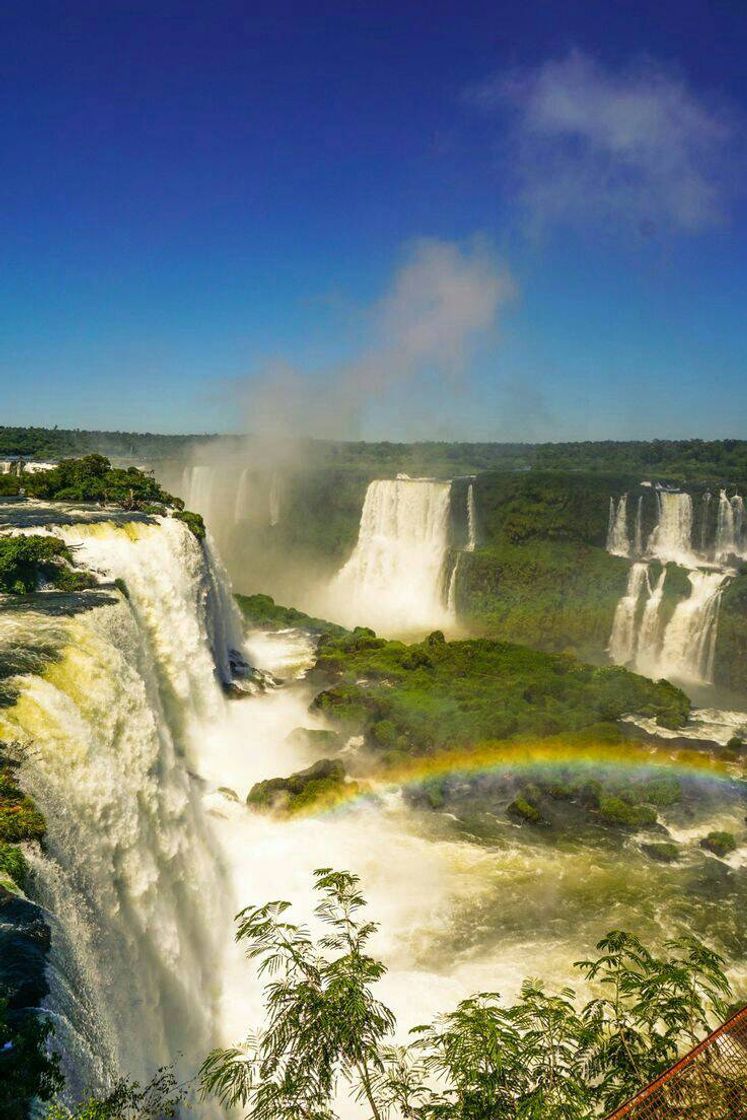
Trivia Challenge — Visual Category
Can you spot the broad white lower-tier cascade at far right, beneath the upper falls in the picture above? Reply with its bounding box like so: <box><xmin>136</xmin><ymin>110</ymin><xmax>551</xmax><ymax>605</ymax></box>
<box><xmin>659</xmin><ymin>571</ymin><xmax>729</xmax><ymax>684</ymax></box>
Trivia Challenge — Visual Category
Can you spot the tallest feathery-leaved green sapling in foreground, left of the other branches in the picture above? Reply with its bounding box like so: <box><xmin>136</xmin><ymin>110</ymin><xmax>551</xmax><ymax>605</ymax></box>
<box><xmin>202</xmin><ymin>868</ymin><xmax>394</xmax><ymax>1120</ymax></box>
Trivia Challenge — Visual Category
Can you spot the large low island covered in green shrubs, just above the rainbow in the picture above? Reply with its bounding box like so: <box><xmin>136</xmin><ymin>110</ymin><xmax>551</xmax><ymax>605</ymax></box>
<box><xmin>312</xmin><ymin>633</ymin><xmax>690</xmax><ymax>752</ymax></box>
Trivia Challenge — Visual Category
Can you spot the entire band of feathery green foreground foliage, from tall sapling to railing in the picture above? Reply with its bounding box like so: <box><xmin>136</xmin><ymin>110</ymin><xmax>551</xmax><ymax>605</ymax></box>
<box><xmin>202</xmin><ymin>869</ymin><xmax>730</xmax><ymax>1120</ymax></box>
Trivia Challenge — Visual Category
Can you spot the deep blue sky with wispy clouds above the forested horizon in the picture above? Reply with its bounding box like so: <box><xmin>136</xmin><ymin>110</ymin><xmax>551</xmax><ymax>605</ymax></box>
<box><xmin>0</xmin><ymin>0</ymin><xmax>747</xmax><ymax>439</ymax></box>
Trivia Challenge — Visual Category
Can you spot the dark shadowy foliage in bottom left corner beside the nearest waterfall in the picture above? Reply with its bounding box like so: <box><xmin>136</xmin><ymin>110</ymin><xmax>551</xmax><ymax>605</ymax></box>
<box><xmin>0</xmin><ymin>996</ymin><xmax>63</xmax><ymax>1120</ymax></box>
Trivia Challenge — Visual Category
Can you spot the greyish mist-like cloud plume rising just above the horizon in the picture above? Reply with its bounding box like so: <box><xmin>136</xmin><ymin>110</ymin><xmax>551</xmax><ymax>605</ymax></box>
<box><xmin>242</xmin><ymin>240</ymin><xmax>514</xmax><ymax>438</ymax></box>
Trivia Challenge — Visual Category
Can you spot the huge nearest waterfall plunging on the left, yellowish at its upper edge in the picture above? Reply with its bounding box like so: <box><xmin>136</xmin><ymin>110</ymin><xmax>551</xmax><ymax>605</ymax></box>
<box><xmin>0</xmin><ymin>520</ymin><xmax>243</xmax><ymax>1102</ymax></box>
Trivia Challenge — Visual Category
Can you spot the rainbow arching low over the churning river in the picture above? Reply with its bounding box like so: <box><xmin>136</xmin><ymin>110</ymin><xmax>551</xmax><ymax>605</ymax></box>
<box><xmin>301</xmin><ymin>738</ymin><xmax>746</xmax><ymax>815</ymax></box>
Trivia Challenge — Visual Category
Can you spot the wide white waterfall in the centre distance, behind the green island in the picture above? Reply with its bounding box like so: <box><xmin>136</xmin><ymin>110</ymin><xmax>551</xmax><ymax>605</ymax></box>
<box><xmin>329</xmin><ymin>478</ymin><xmax>452</xmax><ymax>633</ymax></box>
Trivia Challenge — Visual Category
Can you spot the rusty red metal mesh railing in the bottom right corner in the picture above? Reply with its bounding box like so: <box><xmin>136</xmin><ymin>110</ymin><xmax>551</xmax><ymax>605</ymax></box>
<box><xmin>607</xmin><ymin>1007</ymin><xmax>747</xmax><ymax>1120</ymax></box>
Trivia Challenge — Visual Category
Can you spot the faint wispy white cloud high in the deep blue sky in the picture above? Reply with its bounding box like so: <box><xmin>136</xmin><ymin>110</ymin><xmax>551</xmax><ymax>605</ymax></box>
<box><xmin>478</xmin><ymin>50</ymin><xmax>737</xmax><ymax>233</ymax></box>
